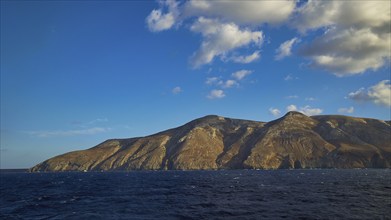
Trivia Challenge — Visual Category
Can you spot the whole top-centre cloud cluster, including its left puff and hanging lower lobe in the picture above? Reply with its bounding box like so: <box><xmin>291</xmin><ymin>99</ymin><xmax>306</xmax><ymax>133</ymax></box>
<box><xmin>146</xmin><ymin>0</ymin><xmax>296</xmax><ymax>68</ymax></box>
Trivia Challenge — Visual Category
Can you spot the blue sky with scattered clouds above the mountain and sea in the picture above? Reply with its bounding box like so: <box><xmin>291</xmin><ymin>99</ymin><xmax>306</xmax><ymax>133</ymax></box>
<box><xmin>0</xmin><ymin>0</ymin><xmax>391</xmax><ymax>169</ymax></box>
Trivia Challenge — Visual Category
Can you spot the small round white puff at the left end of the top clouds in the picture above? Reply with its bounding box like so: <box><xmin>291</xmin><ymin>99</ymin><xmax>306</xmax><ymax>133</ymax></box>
<box><xmin>146</xmin><ymin>0</ymin><xmax>179</xmax><ymax>32</ymax></box>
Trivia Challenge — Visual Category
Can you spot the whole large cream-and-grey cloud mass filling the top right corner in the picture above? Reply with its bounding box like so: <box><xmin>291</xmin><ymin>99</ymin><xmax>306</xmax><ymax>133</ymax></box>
<box><xmin>294</xmin><ymin>1</ymin><xmax>391</xmax><ymax>77</ymax></box>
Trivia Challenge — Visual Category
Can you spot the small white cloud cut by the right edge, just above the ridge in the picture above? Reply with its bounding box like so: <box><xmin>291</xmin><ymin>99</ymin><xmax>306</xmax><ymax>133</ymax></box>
<box><xmin>348</xmin><ymin>80</ymin><xmax>391</xmax><ymax>107</ymax></box>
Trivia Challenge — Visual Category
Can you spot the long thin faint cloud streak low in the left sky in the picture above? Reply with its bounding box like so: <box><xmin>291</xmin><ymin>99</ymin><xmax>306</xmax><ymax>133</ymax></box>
<box><xmin>28</xmin><ymin>127</ymin><xmax>111</xmax><ymax>137</ymax></box>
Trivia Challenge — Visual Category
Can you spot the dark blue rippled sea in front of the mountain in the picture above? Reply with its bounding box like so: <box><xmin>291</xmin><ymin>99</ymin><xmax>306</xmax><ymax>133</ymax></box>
<box><xmin>0</xmin><ymin>169</ymin><xmax>391</xmax><ymax>219</ymax></box>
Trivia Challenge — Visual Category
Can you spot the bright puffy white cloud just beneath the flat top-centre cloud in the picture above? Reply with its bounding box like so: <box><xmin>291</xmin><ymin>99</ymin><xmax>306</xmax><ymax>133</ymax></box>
<box><xmin>190</xmin><ymin>17</ymin><xmax>263</xmax><ymax>68</ymax></box>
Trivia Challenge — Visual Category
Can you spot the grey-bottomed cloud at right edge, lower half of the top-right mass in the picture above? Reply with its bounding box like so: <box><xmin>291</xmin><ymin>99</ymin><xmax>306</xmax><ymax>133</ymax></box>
<box><xmin>301</xmin><ymin>28</ymin><xmax>391</xmax><ymax>77</ymax></box>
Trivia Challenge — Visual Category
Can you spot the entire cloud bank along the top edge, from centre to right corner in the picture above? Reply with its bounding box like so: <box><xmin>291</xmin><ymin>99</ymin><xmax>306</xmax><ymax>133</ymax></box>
<box><xmin>146</xmin><ymin>0</ymin><xmax>391</xmax><ymax>77</ymax></box>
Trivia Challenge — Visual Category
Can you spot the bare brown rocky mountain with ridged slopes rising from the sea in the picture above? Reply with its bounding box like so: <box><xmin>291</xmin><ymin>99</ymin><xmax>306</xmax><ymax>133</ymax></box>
<box><xmin>30</xmin><ymin>112</ymin><xmax>391</xmax><ymax>172</ymax></box>
